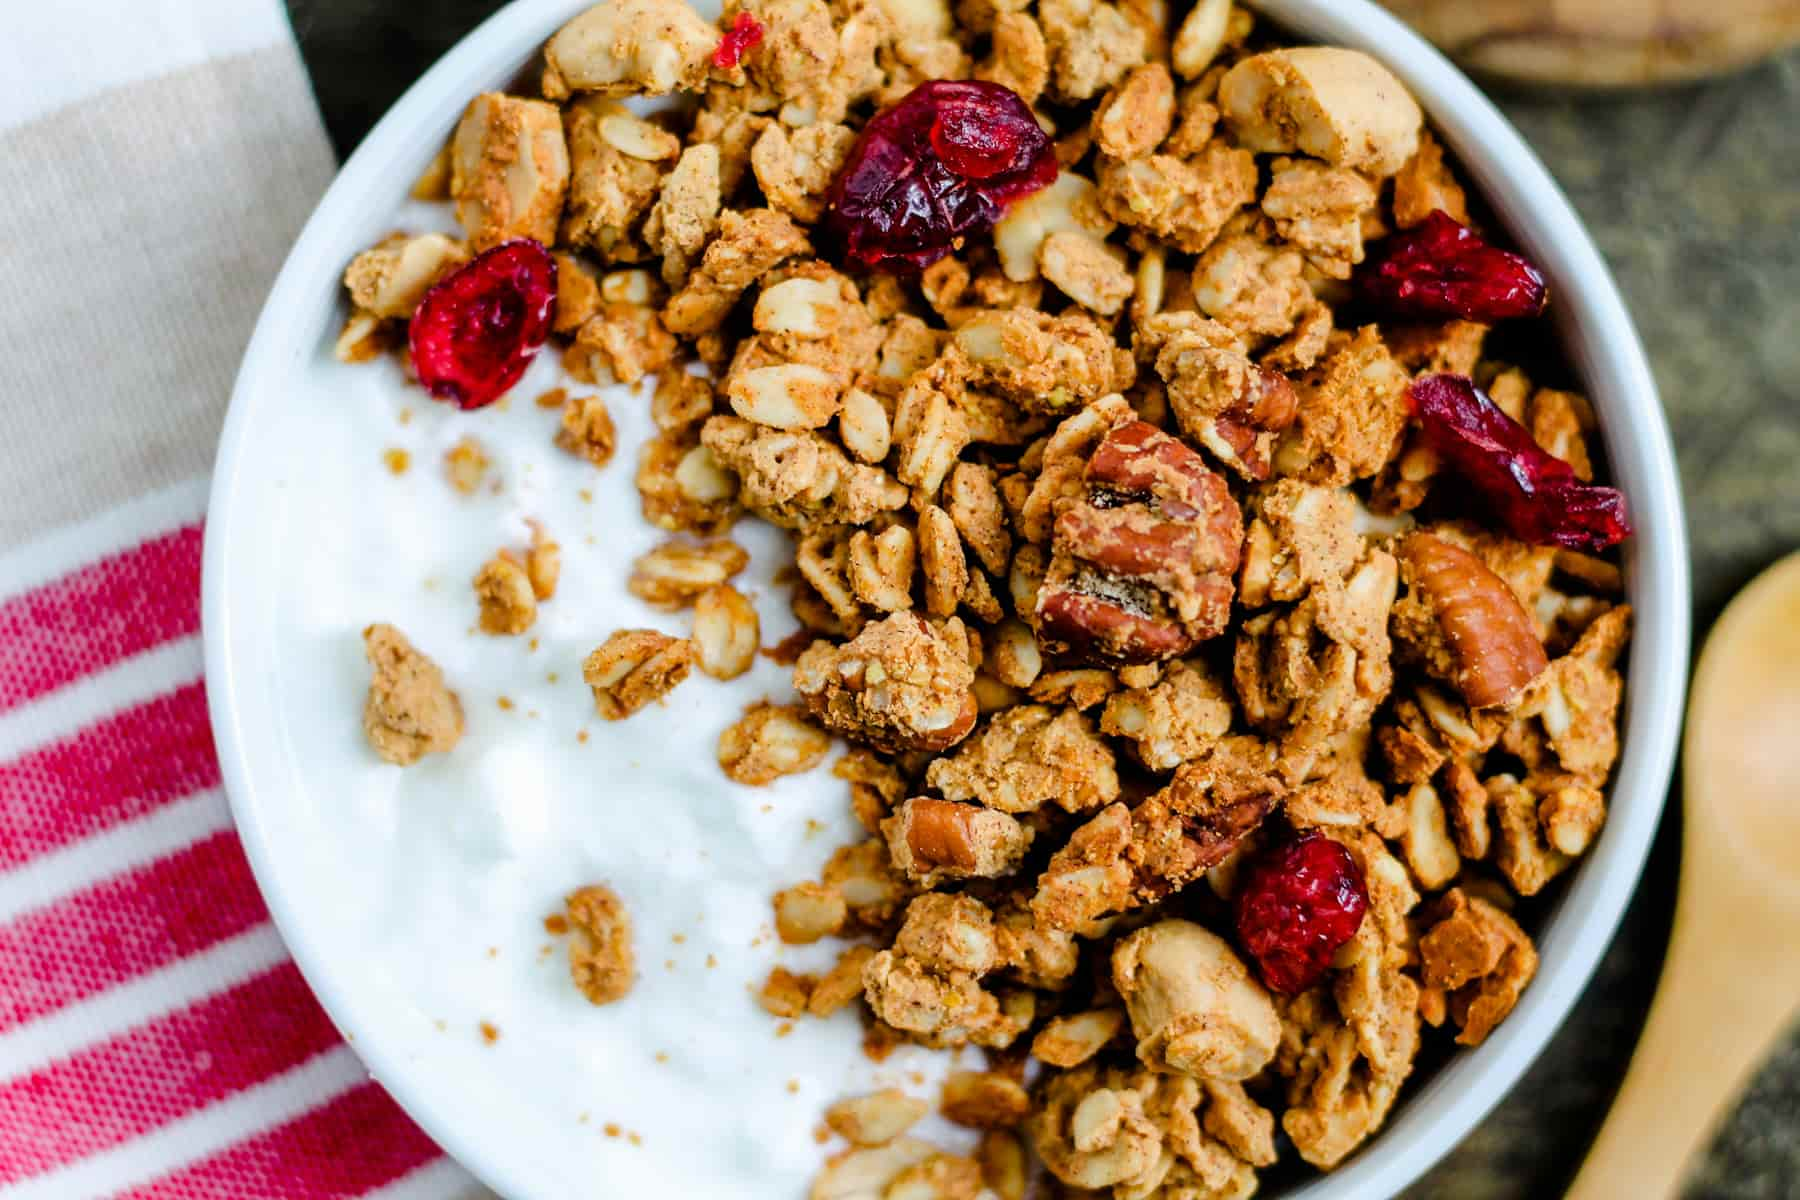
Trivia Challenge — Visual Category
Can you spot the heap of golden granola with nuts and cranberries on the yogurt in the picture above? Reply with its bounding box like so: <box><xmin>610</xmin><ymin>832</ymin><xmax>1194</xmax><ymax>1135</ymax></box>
<box><xmin>344</xmin><ymin>0</ymin><xmax>1631</xmax><ymax>1200</ymax></box>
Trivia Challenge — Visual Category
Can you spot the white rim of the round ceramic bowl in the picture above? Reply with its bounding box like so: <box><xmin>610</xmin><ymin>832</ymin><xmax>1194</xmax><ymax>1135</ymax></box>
<box><xmin>202</xmin><ymin>0</ymin><xmax>1690</xmax><ymax>1200</ymax></box>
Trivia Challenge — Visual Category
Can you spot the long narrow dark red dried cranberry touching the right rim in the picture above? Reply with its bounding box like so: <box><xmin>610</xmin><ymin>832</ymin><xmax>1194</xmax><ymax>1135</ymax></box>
<box><xmin>1411</xmin><ymin>374</ymin><xmax>1631</xmax><ymax>551</ymax></box>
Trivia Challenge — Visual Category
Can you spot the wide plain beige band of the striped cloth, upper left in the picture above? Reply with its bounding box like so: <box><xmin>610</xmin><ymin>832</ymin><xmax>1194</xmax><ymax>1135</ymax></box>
<box><xmin>0</xmin><ymin>43</ymin><xmax>335</xmax><ymax>551</ymax></box>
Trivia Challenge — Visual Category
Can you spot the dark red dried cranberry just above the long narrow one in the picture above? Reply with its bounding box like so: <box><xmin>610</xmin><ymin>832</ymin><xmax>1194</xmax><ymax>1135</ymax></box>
<box><xmin>1357</xmin><ymin>209</ymin><xmax>1548</xmax><ymax>320</ymax></box>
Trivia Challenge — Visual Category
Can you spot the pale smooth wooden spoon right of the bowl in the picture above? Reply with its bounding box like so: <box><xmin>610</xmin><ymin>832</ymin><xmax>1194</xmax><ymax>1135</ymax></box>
<box><xmin>1568</xmin><ymin>554</ymin><xmax>1800</xmax><ymax>1200</ymax></box>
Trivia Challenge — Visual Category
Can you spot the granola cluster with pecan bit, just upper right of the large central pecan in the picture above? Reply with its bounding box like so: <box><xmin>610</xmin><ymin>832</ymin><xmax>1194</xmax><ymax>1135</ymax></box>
<box><xmin>1132</xmin><ymin>313</ymin><xmax>1298</xmax><ymax>480</ymax></box>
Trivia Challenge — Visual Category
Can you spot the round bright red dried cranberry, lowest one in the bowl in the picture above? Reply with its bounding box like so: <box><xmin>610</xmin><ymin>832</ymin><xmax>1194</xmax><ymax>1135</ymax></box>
<box><xmin>1237</xmin><ymin>833</ymin><xmax>1368</xmax><ymax>995</ymax></box>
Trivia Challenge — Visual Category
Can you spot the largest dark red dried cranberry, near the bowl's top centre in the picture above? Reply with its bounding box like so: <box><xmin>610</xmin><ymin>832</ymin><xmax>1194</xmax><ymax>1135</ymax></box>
<box><xmin>826</xmin><ymin>79</ymin><xmax>1057</xmax><ymax>270</ymax></box>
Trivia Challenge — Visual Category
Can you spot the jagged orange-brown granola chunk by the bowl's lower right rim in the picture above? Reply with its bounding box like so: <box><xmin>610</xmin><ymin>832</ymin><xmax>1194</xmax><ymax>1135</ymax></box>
<box><xmin>1418</xmin><ymin>887</ymin><xmax>1537</xmax><ymax>1045</ymax></box>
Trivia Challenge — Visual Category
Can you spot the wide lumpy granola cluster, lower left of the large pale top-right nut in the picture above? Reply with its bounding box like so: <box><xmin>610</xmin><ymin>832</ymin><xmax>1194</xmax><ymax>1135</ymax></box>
<box><xmin>1096</xmin><ymin>140</ymin><xmax>1256</xmax><ymax>254</ymax></box>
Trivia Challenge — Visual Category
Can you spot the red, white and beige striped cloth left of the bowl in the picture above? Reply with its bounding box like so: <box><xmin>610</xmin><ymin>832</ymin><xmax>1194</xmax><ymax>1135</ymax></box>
<box><xmin>0</xmin><ymin>0</ymin><xmax>488</xmax><ymax>1200</ymax></box>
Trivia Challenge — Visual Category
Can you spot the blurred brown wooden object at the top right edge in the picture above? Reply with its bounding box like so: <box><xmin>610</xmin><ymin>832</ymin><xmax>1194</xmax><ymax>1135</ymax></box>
<box><xmin>1382</xmin><ymin>0</ymin><xmax>1800</xmax><ymax>88</ymax></box>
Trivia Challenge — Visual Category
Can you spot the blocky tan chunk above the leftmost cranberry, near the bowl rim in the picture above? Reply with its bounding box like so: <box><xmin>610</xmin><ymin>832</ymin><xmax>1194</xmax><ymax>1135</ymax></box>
<box><xmin>450</xmin><ymin>92</ymin><xmax>569</xmax><ymax>252</ymax></box>
